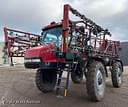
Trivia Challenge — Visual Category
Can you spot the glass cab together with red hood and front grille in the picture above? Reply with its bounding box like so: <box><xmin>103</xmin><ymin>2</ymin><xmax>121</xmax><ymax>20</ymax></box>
<box><xmin>25</xmin><ymin>22</ymin><xmax>64</xmax><ymax>68</ymax></box>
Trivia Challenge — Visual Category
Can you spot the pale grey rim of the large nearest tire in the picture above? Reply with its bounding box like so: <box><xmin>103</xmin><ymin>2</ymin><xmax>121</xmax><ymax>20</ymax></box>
<box><xmin>96</xmin><ymin>70</ymin><xmax>105</xmax><ymax>95</ymax></box>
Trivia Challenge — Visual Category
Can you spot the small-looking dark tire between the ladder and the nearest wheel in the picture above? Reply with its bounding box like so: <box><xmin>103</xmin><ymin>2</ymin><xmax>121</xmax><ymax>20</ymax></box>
<box><xmin>71</xmin><ymin>67</ymin><xmax>83</xmax><ymax>84</ymax></box>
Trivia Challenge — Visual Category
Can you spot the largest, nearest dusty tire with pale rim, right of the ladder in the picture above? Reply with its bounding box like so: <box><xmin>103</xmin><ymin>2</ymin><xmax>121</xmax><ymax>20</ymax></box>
<box><xmin>86</xmin><ymin>61</ymin><xmax>106</xmax><ymax>101</ymax></box>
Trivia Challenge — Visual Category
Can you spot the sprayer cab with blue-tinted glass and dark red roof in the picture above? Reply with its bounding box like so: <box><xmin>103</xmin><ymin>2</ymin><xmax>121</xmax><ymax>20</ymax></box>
<box><xmin>40</xmin><ymin>22</ymin><xmax>62</xmax><ymax>48</ymax></box>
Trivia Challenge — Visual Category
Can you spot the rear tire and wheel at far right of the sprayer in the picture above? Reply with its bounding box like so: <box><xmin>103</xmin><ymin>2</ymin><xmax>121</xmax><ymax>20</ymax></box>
<box><xmin>111</xmin><ymin>62</ymin><xmax>123</xmax><ymax>88</ymax></box>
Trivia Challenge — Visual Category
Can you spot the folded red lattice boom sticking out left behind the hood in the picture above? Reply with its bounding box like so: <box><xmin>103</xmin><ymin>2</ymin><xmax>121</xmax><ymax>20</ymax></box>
<box><xmin>4</xmin><ymin>27</ymin><xmax>40</xmax><ymax>57</ymax></box>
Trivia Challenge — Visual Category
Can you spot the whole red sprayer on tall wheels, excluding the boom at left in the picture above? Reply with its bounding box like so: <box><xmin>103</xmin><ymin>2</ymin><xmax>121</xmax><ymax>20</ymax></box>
<box><xmin>4</xmin><ymin>5</ymin><xmax>123</xmax><ymax>101</ymax></box>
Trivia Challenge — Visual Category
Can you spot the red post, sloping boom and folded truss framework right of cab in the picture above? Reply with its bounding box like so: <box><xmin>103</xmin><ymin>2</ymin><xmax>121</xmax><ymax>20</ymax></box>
<box><xmin>62</xmin><ymin>4</ymin><xmax>120</xmax><ymax>57</ymax></box>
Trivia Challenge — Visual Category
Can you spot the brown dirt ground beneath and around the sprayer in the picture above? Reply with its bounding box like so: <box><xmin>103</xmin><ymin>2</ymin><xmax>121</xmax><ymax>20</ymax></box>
<box><xmin>0</xmin><ymin>66</ymin><xmax>128</xmax><ymax>107</ymax></box>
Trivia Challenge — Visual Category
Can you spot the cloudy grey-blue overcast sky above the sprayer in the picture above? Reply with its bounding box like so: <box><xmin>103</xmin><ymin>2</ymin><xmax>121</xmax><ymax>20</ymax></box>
<box><xmin>0</xmin><ymin>0</ymin><xmax>128</xmax><ymax>41</ymax></box>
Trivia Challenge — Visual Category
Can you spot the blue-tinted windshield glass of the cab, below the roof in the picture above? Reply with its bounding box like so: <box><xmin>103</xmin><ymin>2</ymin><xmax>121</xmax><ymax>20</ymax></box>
<box><xmin>41</xmin><ymin>27</ymin><xmax>62</xmax><ymax>47</ymax></box>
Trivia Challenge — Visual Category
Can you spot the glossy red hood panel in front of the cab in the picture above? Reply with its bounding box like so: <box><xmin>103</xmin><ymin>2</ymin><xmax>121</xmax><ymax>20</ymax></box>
<box><xmin>25</xmin><ymin>44</ymin><xmax>64</xmax><ymax>62</ymax></box>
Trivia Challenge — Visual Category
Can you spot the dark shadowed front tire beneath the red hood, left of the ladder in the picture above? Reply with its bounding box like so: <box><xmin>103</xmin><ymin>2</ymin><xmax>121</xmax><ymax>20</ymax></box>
<box><xmin>36</xmin><ymin>69</ymin><xmax>57</xmax><ymax>93</ymax></box>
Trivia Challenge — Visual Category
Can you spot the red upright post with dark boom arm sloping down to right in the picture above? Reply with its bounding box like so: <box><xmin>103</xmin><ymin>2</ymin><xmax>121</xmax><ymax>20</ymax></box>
<box><xmin>62</xmin><ymin>4</ymin><xmax>111</xmax><ymax>52</ymax></box>
